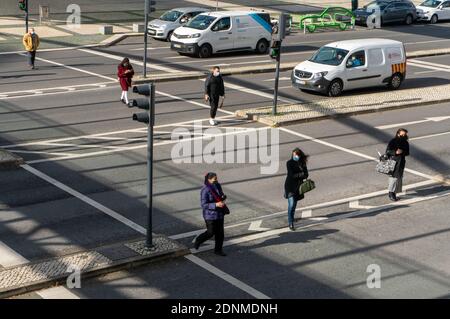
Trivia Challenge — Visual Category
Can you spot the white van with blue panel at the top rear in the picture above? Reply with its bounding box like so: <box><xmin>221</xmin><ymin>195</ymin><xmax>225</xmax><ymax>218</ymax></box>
<box><xmin>171</xmin><ymin>11</ymin><xmax>272</xmax><ymax>58</ymax></box>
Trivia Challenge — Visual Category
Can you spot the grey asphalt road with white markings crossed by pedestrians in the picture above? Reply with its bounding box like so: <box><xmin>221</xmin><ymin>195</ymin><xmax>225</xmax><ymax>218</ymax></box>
<box><xmin>0</xmin><ymin>24</ymin><xmax>450</xmax><ymax>298</ymax></box>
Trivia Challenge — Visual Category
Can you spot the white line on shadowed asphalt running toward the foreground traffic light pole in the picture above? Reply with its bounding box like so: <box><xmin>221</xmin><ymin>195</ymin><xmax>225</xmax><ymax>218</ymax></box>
<box><xmin>21</xmin><ymin>164</ymin><xmax>147</xmax><ymax>235</ymax></box>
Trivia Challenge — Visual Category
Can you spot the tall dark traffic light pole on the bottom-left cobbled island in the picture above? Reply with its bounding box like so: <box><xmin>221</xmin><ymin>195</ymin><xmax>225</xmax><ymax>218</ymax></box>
<box><xmin>146</xmin><ymin>83</ymin><xmax>155</xmax><ymax>248</ymax></box>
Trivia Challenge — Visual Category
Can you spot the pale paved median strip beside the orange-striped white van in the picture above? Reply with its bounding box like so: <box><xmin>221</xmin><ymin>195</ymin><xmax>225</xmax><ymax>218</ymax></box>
<box><xmin>236</xmin><ymin>84</ymin><xmax>450</xmax><ymax>127</ymax></box>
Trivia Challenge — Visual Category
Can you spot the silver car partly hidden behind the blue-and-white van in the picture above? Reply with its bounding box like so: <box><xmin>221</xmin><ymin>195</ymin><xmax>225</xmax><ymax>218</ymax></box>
<box><xmin>148</xmin><ymin>7</ymin><xmax>210</xmax><ymax>41</ymax></box>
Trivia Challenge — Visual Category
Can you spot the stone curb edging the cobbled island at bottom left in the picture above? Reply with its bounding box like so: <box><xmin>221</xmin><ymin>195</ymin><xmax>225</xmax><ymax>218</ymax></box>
<box><xmin>0</xmin><ymin>236</ymin><xmax>191</xmax><ymax>299</ymax></box>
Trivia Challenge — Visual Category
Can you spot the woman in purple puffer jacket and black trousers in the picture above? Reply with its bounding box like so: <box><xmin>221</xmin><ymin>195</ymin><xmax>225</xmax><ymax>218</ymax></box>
<box><xmin>194</xmin><ymin>173</ymin><xmax>230</xmax><ymax>256</ymax></box>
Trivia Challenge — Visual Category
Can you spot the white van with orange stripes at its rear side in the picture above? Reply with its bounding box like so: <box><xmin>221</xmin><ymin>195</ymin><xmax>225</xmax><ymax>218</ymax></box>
<box><xmin>291</xmin><ymin>39</ymin><xmax>406</xmax><ymax>96</ymax></box>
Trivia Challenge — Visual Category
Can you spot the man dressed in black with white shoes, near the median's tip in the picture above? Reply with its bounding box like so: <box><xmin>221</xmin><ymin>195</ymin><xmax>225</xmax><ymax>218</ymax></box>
<box><xmin>205</xmin><ymin>66</ymin><xmax>225</xmax><ymax>125</ymax></box>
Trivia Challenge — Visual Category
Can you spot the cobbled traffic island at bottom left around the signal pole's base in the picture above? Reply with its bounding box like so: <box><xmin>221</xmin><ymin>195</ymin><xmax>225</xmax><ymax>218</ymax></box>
<box><xmin>0</xmin><ymin>235</ymin><xmax>190</xmax><ymax>298</ymax></box>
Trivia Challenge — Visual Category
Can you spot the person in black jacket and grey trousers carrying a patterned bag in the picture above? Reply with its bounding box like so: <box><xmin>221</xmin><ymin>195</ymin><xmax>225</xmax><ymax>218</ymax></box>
<box><xmin>386</xmin><ymin>128</ymin><xmax>409</xmax><ymax>201</ymax></box>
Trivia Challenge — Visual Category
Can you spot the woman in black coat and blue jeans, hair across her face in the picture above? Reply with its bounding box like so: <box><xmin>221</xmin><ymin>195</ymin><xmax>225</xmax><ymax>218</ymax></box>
<box><xmin>284</xmin><ymin>148</ymin><xmax>308</xmax><ymax>230</ymax></box>
